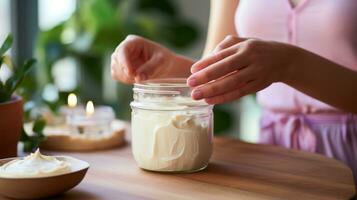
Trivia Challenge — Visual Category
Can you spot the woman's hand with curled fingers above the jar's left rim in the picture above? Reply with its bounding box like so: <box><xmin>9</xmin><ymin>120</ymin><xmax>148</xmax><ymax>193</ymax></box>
<box><xmin>111</xmin><ymin>35</ymin><xmax>175</xmax><ymax>84</ymax></box>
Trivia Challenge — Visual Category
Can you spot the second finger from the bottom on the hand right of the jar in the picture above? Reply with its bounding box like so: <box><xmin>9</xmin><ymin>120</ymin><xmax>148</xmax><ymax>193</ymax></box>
<box><xmin>192</xmin><ymin>67</ymin><xmax>254</xmax><ymax>100</ymax></box>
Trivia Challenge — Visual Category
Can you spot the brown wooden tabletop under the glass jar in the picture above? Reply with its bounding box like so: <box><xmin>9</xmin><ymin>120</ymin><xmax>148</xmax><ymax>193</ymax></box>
<box><xmin>43</xmin><ymin>138</ymin><xmax>355</xmax><ymax>200</ymax></box>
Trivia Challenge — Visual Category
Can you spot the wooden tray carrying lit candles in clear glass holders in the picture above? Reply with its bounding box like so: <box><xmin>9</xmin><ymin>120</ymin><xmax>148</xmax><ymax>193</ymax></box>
<box><xmin>41</xmin><ymin>93</ymin><xmax>126</xmax><ymax>151</ymax></box>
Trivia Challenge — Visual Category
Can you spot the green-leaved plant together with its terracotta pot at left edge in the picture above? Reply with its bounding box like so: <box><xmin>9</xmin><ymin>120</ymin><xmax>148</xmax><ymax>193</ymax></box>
<box><xmin>0</xmin><ymin>35</ymin><xmax>35</xmax><ymax>158</ymax></box>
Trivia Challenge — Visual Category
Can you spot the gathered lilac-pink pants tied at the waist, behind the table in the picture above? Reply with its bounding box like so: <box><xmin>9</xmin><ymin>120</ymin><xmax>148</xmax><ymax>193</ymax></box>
<box><xmin>260</xmin><ymin>111</ymin><xmax>357</xmax><ymax>183</ymax></box>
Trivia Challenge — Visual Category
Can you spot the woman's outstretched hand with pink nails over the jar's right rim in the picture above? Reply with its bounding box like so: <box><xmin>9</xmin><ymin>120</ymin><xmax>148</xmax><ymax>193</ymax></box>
<box><xmin>187</xmin><ymin>36</ymin><xmax>297</xmax><ymax>104</ymax></box>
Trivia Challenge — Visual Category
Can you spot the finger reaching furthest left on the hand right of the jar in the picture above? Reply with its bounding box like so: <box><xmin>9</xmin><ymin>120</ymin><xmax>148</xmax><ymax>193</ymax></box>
<box><xmin>187</xmin><ymin>52</ymin><xmax>249</xmax><ymax>87</ymax></box>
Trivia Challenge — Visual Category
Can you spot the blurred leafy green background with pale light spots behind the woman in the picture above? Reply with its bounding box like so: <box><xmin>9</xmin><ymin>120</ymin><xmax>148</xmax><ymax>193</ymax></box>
<box><xmin>0</xmin><ymin>0</ymin><xmax>260</xmax><ymax>142</ymax></box>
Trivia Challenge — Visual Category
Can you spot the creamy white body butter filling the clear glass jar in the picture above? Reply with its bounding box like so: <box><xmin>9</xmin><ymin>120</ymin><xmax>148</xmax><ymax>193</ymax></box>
<box><xmin>132</xmin><ymin>110</ymin><xmax>212</xmax><ymax>171</ymax></box>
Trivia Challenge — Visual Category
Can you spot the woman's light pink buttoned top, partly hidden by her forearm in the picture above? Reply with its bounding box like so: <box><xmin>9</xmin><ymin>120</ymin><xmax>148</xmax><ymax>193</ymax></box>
<box><xmin>236</xmin><ymin>0</ymin><xmax>357</xmax><ymax>113</ymax></box>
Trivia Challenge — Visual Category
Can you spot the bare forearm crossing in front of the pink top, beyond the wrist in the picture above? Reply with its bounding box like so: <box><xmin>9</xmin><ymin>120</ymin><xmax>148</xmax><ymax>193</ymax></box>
<box><xmin>283</xmin><ymin>46</ymin><xmax>357</xmax><ymax>113</ymax></box>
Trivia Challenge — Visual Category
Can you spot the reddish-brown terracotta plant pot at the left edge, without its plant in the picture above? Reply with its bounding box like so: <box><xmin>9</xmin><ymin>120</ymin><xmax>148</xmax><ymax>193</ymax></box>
<box><xmin>0</xmin><ymin>96</ymin><xmax>23</xmax><ymax>158</ymax></box>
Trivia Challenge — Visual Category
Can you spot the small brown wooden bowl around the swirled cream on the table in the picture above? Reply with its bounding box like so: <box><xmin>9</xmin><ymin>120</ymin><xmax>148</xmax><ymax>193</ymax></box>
<box><xmin>0</xmin><ymin>156</ymin><xmax>89</xmax><ymax>199</ymax></box>
